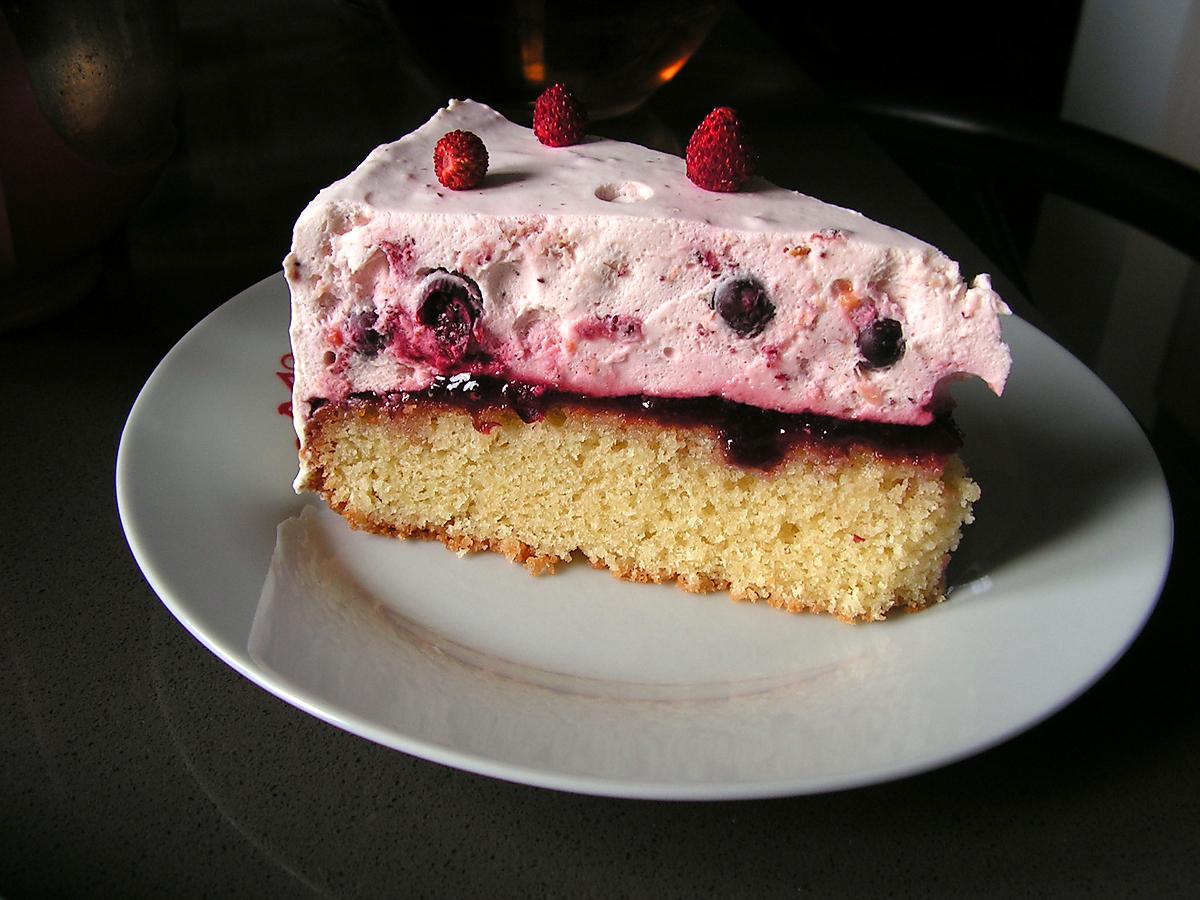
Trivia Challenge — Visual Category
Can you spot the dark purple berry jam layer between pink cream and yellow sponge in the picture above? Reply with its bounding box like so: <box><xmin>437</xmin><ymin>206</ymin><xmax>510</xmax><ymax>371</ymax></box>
<box><xmin>304</xmin><ymin>373</ymin><xmax>962</xmax><ymax>472</ymax></box>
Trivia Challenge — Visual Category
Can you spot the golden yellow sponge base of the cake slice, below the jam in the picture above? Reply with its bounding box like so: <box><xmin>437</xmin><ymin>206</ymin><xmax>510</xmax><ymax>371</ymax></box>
<box><xmin>302</xmin><ymin>404</ymin><xmax>979</xmax><ymax>620</ymax></box>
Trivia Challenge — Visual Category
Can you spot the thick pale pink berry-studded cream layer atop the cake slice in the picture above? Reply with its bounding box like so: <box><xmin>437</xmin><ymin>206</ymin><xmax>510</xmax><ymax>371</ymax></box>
<box><xmin>284</xmin><ymin>101</ymin><xmax>1010</xmax><ymax>480</ymax></box>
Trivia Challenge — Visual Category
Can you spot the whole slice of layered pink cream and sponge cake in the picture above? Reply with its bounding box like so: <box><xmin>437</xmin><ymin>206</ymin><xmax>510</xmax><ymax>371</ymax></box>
<box><xmin>284</xmin><ymin>101</ymin><xmax>1009</xmax><ymax>620</ymax></box>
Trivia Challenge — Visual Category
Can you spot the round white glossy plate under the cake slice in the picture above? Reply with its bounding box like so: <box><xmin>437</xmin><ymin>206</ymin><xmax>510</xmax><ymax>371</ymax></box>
<box><xmin>116</xmin><ymin>277</ymin><xmax>1171</xmax><ymax>799</ymax></box>
